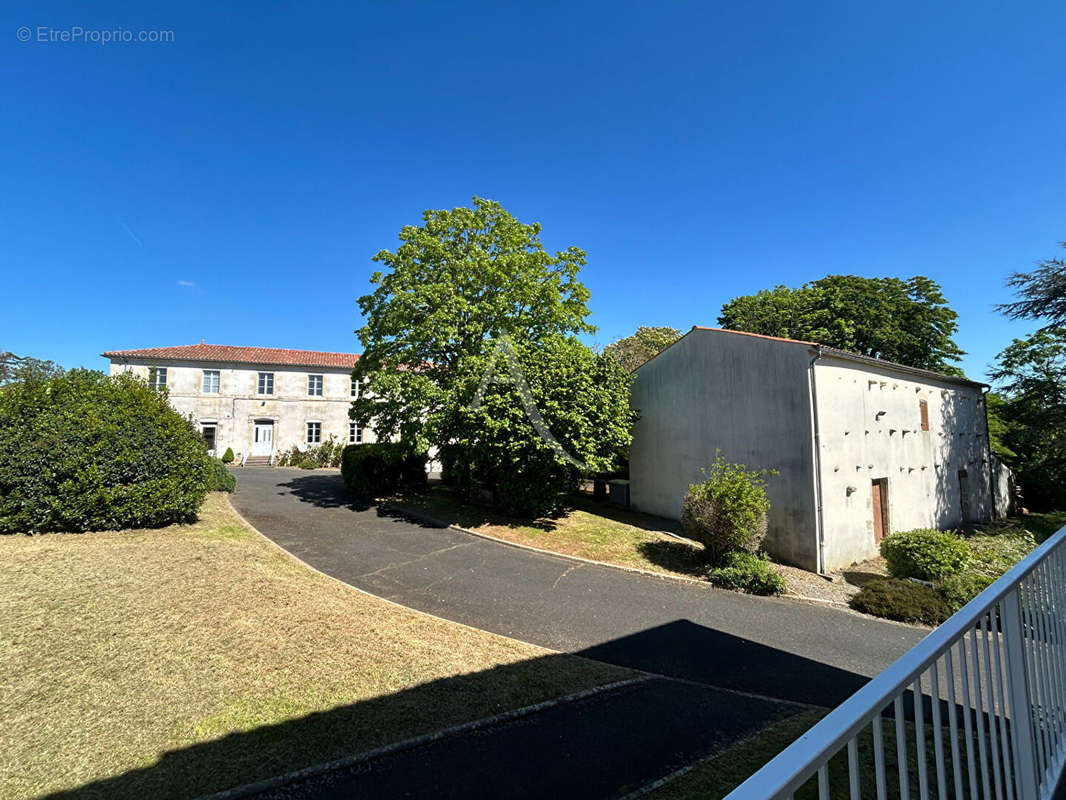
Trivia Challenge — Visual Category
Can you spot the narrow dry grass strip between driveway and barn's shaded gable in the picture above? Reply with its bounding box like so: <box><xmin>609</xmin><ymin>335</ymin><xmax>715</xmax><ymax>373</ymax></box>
<box><xmin>391</xmin><ymin>486</ymin><xmax>707</xmax><ymax>577</ymax></box>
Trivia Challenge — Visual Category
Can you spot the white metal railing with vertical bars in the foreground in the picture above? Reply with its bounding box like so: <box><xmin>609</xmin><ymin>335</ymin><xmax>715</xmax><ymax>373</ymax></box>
<box><xmin>726</xmin><ymin>527</ymin><xmax>1066</xmax><ymax>800</ymax></box>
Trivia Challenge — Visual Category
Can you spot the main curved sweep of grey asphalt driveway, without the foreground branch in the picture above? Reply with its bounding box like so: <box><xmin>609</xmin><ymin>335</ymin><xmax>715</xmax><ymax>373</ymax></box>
<box><xmin>233</xmin><ymin>467</ymin><xmax>924</xmax><ymax>705</ymax></box>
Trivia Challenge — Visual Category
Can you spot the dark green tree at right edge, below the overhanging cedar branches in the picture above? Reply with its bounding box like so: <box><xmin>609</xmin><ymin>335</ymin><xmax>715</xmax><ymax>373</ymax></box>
<box><xmin>991</xmin><ymin>327</ymin><xmax>1066</xmax><ymax>511</ymax></box>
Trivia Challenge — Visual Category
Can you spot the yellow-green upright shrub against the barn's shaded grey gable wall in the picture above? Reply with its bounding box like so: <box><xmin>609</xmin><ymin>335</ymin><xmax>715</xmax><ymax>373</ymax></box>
<box><xmin>681</xmin><ymin>453</ymin><xmax>770</xmax><ymax>562</ymax></box>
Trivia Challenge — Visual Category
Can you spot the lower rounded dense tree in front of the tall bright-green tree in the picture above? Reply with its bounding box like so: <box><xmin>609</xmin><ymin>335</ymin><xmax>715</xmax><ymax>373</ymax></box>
<box><xmin>441</xmin><ymin>336</ymin><xmax>635</xmax><ymax>517</ymax></box>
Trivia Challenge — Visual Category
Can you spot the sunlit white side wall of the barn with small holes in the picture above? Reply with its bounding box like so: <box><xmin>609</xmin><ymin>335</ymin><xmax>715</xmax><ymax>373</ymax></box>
<box><xmin>814</xmin><ymin>355</ymin><xmax>992</xmax><ymax>570</ymax></box>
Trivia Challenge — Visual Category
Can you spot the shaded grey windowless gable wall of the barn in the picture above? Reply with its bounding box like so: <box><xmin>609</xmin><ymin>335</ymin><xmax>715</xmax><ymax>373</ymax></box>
<box><xmin>630</xmin><ymin>329</ymin><xmax>818</xmax><ymax>571</ymax></box>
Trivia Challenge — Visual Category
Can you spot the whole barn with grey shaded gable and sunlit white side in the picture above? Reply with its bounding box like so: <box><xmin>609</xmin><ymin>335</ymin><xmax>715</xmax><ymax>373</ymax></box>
<box><xmin>630</xmin><ymin>326</ymin><xmax>995</xmax><ymax>573</ymax></box>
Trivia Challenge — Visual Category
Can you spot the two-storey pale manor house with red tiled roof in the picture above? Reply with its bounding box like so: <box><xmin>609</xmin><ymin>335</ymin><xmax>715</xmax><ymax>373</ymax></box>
<box><xmin>103</xmin><ymin>342</ymin><xmax>374</xmax><ymax>463</ymax></box>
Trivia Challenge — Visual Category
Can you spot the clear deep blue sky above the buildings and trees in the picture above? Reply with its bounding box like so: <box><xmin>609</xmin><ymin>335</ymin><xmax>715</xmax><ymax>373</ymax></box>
<box><xmin>0</xmin><ymin>0</ymin><xmax>1066</xmax><ymax>377</ymax></box>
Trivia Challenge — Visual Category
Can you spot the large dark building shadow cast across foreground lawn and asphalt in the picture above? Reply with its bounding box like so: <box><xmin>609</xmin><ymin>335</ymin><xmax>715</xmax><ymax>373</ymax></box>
<box><xmin>43</xmin><ymin>620</ymin><xmax>882</xmax><ymax>798</ymax></box>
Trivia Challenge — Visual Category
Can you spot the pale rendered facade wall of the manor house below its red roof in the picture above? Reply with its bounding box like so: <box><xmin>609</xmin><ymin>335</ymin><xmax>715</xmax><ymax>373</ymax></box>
<box><xmin>111</xmin><ymin>359</ymin><xmax>375</xmax><ymax>455</ymax></box>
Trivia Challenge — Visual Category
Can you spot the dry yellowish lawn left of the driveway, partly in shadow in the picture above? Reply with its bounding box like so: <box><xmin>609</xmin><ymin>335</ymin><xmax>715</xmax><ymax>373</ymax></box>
<box><xmin>0</xmin><ymin>495</ymin><xmax>630</xmax><ymax>798</ymax></box>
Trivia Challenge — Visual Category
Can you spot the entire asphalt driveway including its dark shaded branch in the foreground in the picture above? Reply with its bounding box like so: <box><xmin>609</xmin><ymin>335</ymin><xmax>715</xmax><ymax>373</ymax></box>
<box><xmin>233</xmin><ymin>468</ymin><xmax>923</xmax><ymax>800</ymax></box>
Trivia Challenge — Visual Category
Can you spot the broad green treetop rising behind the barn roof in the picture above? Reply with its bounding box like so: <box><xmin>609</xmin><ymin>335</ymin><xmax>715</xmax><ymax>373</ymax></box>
<box><xmin>718</xmin><ymin>275</ymin><xmax>965</xmax><ymax>374</ymax></box>
